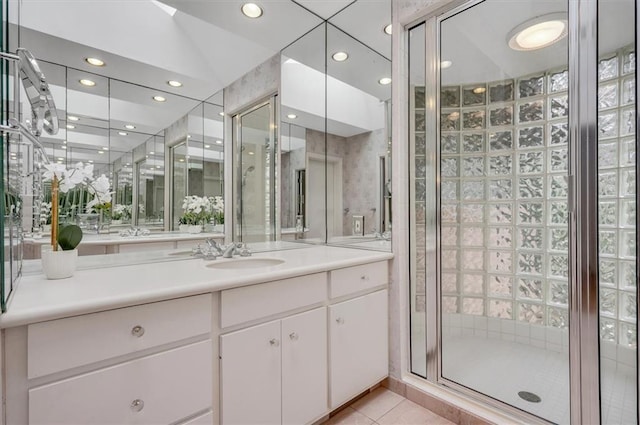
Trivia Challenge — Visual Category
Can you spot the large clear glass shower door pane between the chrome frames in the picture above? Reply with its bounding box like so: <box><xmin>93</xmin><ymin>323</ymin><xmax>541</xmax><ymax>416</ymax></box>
<box><xmin>436</xmin><ymin>0</ymin><xmax>570</xmax><ymax>423</ymax></box>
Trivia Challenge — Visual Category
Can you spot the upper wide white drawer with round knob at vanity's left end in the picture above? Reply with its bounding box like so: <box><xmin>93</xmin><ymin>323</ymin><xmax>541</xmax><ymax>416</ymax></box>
<box><xmin>27</xmin><ymin>294</ymin><xmax>212</xmax><ymax>379</ymax></box>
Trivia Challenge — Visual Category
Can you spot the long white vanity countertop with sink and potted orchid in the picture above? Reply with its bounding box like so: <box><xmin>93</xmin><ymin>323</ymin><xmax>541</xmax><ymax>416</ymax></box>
<box><xmin>0</xmin><ymin>242</ymin><xmax>393</xmax><ymax>328</ymax></box>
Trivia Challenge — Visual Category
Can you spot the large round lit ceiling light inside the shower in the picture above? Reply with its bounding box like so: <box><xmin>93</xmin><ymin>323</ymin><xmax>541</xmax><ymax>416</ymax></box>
<box><xmin>507</xmin><ymin>12</ymin><xmax>568</xmax><ymax>51</ymax></box>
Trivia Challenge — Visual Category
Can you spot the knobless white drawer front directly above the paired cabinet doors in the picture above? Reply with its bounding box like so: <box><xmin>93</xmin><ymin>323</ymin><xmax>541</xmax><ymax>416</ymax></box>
<box><xmin>220</xmin><ymin>273</ymin><xmax>327</xmax><ymax>328</ymax></box>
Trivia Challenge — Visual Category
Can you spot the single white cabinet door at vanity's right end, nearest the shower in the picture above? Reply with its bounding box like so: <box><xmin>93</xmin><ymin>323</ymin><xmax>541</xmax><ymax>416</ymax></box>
<box><xmin>329</xmin><ymin>289</ymin><xmax>389</xmax><ymax>409</ymax></box>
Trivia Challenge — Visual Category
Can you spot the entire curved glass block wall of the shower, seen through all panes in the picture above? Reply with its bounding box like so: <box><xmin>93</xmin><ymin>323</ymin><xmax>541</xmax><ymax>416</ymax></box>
<box><xmin>412</xmin><ymin>51</ymin><xmax>637</xmax><ymax>346</ymax></box>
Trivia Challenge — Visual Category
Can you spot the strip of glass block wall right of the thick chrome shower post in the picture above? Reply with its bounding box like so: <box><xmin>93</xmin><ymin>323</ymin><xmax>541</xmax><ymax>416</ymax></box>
<box><xmin>598</xmin><ymin>50</ymin><xmax>638</xmax><ymax>347</ymax></box>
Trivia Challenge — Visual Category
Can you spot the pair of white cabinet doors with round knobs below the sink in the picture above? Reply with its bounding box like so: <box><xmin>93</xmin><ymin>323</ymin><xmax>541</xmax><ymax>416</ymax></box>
<box><xmin>220</xmin><ymin>307</ymin><xmax>327</xmax><ymax>425</ymax></box>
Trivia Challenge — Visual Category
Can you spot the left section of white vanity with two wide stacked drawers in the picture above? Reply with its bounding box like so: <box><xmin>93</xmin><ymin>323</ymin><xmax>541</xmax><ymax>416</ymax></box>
<box><xmin>5</xmin><ymin>294</ymin><xmax>217</xmax><ymax>425</ymax></box>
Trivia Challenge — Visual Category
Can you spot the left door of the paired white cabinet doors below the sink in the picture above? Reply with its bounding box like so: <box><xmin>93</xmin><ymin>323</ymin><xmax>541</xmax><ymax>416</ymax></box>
<box><xmin>220</xmin><ymin>321</ymin><xmax>281</xmax><ymax>425</ymax></box>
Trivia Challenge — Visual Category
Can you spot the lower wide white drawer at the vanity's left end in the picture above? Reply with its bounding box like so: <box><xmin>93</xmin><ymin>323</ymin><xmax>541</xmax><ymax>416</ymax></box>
<box><xmin>29</xmin><ymin>340</ymin><xmax>213</xmax><ymax>425</ymax></box>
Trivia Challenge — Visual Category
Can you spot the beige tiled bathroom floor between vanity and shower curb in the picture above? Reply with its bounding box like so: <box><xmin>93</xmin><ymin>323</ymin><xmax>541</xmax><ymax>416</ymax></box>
<box><xmin>324</xmin><ymin>387</ymin><xmax>453</xmax><ymax>425</ymax></box>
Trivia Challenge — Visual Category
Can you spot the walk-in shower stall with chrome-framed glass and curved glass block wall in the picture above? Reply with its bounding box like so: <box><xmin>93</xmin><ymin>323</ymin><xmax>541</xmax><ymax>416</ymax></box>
<box><xmin>406</xmin><ymin>0</ymin><xmax>638</xmax><ymax>424</ymax></box>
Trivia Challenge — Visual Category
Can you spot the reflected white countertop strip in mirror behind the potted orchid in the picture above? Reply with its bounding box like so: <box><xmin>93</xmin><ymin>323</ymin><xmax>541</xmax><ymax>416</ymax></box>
<box><xmin>24</xmin><ymin>232</ymin><xmax>224</xmax><ymax>245</ymax></box>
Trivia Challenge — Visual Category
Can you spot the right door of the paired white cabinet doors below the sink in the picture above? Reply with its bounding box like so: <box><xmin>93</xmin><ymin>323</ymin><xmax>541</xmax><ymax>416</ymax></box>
<box><xmin>282</xmin><ymin>307</ymin><xmax>328</xmax><ymax>425</ymax></box>
